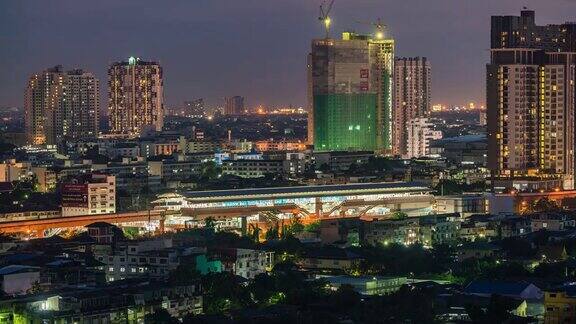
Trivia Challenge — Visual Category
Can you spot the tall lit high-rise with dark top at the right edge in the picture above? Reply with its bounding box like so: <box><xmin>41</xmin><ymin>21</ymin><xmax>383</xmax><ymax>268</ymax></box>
<box><xmin>486</xmin><ymin>11</ymin><xmax>576</xmax><ymax>189</ymax></box>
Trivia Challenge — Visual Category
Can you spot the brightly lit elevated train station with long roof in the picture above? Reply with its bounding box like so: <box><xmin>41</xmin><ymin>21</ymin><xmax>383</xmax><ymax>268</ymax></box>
<box><xmin>153</xmin><ymin>182</ymin><xmax>434</xmax><ymax>220</ymax></box>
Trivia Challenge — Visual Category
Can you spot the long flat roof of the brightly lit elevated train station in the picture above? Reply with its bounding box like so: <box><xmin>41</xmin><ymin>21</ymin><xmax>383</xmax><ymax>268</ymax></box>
<box><xmin>183</xmin><ymin>182</ymin><xmax>431</xmax><ymax>202</ymax></box>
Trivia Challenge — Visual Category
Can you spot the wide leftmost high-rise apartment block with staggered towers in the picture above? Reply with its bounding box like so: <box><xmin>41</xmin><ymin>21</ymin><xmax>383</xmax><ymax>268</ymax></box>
<box><xmin>24</xmin><ymin>65</ymin><xmax>100</xmax><ymax>145</ymax></box>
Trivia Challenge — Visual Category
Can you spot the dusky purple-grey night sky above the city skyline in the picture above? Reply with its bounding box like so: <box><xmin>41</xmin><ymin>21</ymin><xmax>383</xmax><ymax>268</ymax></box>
<box><xmin>0</xmin><ymin>0</ymin><xmax>576</xmax><ymax>108</ymax></box>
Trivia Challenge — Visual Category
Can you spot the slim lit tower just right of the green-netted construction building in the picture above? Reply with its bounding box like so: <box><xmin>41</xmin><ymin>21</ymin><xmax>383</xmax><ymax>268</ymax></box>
<box><xmin>392</xmin><ymin>57</ymin><xmax>431</xmax><ymax>156</ymax></box>
